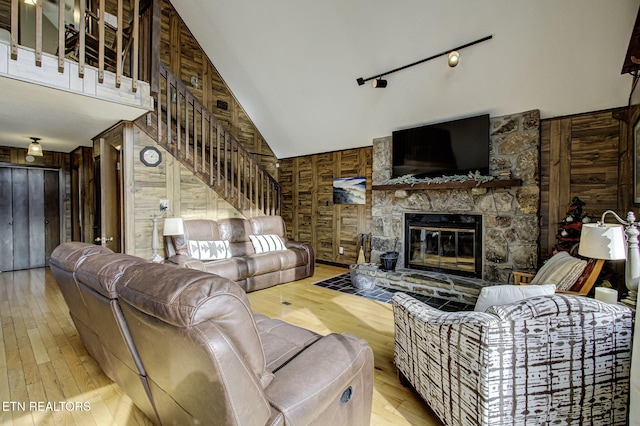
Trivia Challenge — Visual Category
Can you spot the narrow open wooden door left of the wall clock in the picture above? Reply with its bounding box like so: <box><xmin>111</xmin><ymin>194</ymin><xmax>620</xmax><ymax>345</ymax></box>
<box><xmin>99</xmin><ymin>138</ymin><xmax>122</xmax><ymax>253</ymax></box>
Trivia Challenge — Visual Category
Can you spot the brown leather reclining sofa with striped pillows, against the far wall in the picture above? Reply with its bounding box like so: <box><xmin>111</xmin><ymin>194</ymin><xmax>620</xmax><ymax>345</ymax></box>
<box><xmin>164</xmin><ymin>216</ymin><xmax>315</xmax><ymax>292</ymax></box>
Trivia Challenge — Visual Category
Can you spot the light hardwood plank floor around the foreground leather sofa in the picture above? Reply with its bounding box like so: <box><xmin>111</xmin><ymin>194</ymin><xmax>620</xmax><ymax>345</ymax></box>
<box><xmin>0</xmin><ymin>265</ymin><xmax>441</xmax><ymax>426</ymax></box>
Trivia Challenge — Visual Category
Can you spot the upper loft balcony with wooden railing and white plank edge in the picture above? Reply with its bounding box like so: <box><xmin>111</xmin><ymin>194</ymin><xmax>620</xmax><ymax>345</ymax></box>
<box><xmin>0</xmin><ymin>0</ymin><xmax>153</xmax><ymax>111</ymax></box>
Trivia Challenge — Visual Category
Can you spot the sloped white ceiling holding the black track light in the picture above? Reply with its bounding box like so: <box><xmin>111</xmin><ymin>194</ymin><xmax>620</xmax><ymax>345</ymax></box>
<box><xmin>172</xmin><ymin>0</ymin><xmax>640</xmax><ymax>158</ymax></box>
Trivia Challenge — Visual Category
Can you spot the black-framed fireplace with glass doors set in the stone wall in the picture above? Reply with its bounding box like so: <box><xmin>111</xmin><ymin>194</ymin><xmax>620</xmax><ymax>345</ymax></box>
<box><xmin>404</xmin><ymin>213</ymin><xmax>482</xmax><ymax>277</ymax></box>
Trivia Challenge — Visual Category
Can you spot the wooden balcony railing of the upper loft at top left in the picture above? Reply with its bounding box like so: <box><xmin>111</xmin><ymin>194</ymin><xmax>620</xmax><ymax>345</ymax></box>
<box><xmin>10</xmin><ymin>0</ymin><xmax>152</xmax><ymax>92</ymax></box>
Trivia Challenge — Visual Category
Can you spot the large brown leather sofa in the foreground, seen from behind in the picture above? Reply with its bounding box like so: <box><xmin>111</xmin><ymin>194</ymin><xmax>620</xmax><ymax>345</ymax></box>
<box><xmin>51</xmin><ymin>243</ymin><xmax>373</xmax><ymax>425</ymax></box>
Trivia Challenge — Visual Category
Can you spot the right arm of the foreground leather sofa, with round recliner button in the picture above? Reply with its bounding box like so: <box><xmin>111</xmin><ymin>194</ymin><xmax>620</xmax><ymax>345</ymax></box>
<box><xmin>265</xmin><ymin>333</ymin><xmax>373</xmax><ymax>425</ymax></box>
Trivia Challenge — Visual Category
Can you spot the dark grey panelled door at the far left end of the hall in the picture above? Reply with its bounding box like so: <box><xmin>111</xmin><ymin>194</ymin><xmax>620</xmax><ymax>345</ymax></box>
<box><xmin>0</xmin><ymin>167</ymin><xmax>60</xmax><ymax>271</ymax></box>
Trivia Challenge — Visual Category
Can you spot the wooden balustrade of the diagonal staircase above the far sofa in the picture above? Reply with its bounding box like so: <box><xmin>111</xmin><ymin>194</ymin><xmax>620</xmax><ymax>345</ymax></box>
<box><xmin>136</xmin><ymin>64</ymin><xmax>281</xmax><ymax>217</ymax></box>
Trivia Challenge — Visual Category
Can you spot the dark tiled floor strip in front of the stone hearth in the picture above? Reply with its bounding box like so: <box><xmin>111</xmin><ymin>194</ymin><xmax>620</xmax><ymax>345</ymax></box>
<box><xmin>314</xmin><ymin>273</ymin><xmax>473</xmax><ymax>312</ymax></box>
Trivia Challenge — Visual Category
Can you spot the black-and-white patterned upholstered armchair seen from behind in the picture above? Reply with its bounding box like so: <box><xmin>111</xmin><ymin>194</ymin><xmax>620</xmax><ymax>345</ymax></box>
<box><xmin>393</xmin><ymin>293</ymin><xmax>632</xmax><ymax>426</ymax></box>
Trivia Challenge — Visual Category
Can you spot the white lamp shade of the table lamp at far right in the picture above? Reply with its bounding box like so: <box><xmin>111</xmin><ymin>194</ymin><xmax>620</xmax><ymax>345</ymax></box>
<box><xmin>578</xmin><ymin>223</ymin><xmax>627</xmax><ymax>260</ymax></box>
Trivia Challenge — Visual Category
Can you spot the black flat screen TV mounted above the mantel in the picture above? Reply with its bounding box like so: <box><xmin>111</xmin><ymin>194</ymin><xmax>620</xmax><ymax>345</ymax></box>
<box><xmin>392</xmin><ymin>114</ymin><xmax>489</xmax><ymax>178</ymax></box>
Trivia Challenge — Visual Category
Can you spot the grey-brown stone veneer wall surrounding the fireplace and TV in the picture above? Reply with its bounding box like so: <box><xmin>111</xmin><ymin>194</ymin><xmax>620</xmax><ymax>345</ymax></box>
<box><xmin>371</xmin><ymin>110</ymin><xmax>540</xmax><ymax>282</ymax></box>
